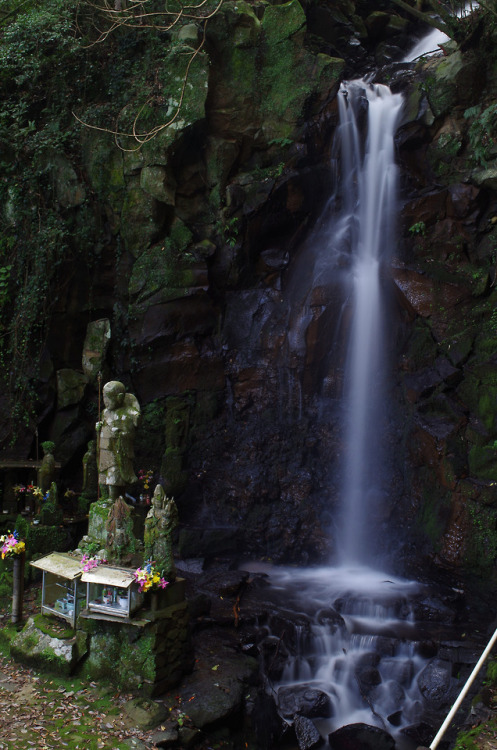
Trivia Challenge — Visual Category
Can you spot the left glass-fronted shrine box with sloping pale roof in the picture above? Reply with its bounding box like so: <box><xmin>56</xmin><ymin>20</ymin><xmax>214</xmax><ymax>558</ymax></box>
<box><xmin>31</xmin><ymin>552</ymin><xmax>86</xmax><ymax>628</ymax></box>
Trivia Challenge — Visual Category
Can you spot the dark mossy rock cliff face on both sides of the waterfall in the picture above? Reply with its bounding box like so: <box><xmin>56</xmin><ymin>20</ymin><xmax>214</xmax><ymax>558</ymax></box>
<box><xmin>0</xmin><ymin>0</ymin><xmax>497</xmax><ymax>573</ymax></box>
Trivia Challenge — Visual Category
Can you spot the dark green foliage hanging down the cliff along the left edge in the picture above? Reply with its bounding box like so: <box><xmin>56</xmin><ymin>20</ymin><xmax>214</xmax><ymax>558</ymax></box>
<box><xmin>0</xmin><ymin>0</ymin><xmax>96</xmax><ymax>442</ymax></box>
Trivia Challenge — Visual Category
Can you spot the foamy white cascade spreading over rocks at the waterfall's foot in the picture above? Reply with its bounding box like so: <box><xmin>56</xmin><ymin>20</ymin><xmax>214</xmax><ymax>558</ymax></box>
<box><xmin>260</xmin><ymin>565</ymin><xmax>426</xmax><ymax>748</ymax></box>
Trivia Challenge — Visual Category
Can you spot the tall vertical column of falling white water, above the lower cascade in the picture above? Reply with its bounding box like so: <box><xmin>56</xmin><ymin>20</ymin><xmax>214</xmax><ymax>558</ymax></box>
<box><xmin>338</xmin><ymin>80</ymin><xmax>403</xmax><ymax>564</ymax></box>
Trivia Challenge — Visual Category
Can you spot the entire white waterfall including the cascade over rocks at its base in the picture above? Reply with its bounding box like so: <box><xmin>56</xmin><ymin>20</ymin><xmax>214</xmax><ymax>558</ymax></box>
<box><xmin>254</xmin><ymin>73</ymin><xmax>466</xmax><ymax>748</ymax></box>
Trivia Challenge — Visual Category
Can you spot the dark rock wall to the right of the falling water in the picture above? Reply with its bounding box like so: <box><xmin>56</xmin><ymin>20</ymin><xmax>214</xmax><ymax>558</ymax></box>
<box><xmin>392</xmin><ymin>32</ymin><xmax>497</xmax><ymax>577</ymax></box>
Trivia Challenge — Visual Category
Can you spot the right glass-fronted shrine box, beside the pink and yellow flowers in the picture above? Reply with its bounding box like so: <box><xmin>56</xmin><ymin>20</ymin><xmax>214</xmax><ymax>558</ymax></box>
<box><xmin>81</xmin><ymin>565</ymin><xmax>143</xmax><ymax>618</ymax></box>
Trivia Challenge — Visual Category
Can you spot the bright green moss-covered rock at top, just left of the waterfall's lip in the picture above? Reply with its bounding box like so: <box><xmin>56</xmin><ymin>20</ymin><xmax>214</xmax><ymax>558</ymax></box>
<box><xmin>207</xmin><ymin>0</ymin><xmax>344</xmax><ymax>143</ymax></box>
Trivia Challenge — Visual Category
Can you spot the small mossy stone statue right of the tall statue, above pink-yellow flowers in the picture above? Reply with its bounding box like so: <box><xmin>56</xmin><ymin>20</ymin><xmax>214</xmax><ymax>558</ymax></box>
<box><xmin>144</xmin><ymin>484</ymin><xmax>179</xmax><ymax>583</ymax></box>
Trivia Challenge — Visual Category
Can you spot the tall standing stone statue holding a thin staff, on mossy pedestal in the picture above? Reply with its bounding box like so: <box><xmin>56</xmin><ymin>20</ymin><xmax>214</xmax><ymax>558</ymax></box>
<box><xmin>96</xmin><ymin>380</ymin><xmax>140</xmax><ymax>500</ymax></box>
